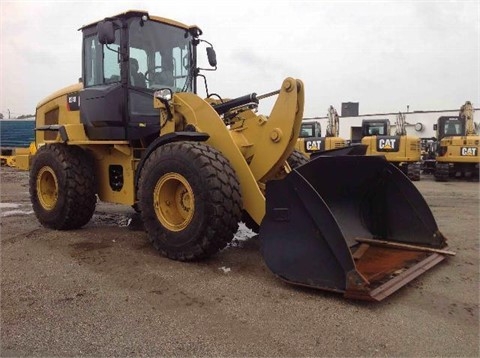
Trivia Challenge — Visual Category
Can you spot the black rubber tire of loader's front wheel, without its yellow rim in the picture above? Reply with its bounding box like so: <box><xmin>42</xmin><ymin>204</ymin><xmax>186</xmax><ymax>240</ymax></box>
<box><xmin>138</xmin><ymin>142</ymin><xmax>242</xmax><ymax>261</ymax></box>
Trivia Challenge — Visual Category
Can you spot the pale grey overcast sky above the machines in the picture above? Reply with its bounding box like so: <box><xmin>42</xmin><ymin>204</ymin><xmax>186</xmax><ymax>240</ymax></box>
<box><xmin>0</xmin><ymin>0</ymin><xmax>480</xmax><ymax>117</ymax></box>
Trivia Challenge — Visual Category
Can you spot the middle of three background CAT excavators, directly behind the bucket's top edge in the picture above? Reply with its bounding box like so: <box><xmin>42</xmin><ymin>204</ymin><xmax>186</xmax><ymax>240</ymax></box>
<box><xmin>362</xmin><ymin>112</ymin><xmax>422</xmax><ymax>181</ymax></box>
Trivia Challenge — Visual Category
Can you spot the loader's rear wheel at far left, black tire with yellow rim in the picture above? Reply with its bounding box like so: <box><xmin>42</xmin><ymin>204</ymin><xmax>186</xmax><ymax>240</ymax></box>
<box><xmin>29</xmin><ymin>144</ymin><xmax>97</xmax><ymax>230</ymax></box>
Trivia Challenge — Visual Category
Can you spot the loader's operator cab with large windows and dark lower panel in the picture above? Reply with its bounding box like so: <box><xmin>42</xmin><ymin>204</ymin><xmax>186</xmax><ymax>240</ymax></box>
<box><xmin>80</xmin><ymin>11</ymin><xmax>216</xmax><ymax>140</ymax></box>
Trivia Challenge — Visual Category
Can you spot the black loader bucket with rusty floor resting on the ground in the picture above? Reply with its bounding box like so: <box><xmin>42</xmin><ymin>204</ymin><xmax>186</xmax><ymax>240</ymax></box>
<box><xmin>260</xmin><ymin>155</ymin><xmax>448</xmax><ymax>301</ymax></box>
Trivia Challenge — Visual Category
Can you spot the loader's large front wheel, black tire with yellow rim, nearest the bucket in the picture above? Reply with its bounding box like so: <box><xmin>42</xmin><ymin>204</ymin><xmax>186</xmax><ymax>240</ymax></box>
<box><xmin>138</xmin><ymin>142</ymin><xmax>242</xmax><ymax>261</ymax></box>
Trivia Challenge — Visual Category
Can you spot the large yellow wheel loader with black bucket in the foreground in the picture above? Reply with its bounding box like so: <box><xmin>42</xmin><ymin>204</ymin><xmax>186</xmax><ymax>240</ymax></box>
<box><xmin>30</xmin><ymin>11</ymin><xmax>449</xmax><ymax>300</ymax></box>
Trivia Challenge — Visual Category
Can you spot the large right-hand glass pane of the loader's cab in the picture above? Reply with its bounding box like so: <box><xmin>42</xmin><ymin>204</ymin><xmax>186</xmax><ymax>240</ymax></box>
<box><xmin>129</xmin><ymin>18</ymin><xmax>192</xmax><ymax>92</ymax></box>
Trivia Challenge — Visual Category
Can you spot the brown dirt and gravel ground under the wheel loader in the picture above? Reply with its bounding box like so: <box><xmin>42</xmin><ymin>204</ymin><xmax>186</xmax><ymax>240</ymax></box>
<box><xmin>0</xmin><ymin>167</ymin><xmax>480</xmax><ymax>357</ymax></box>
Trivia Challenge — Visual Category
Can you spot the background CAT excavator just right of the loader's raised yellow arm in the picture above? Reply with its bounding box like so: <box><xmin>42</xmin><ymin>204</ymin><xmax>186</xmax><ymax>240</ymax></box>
<box><xmin>295</xmin><ymin>106</ymin><xmax>347</xmax><ymax>157</ymax></box>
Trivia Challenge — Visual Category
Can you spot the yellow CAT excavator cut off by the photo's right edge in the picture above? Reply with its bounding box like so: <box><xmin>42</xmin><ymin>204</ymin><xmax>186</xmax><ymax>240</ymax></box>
<box><xmin>434</xmin><ymin>101</ymin><xmax>480</xmax><ymax>181</ymax></box>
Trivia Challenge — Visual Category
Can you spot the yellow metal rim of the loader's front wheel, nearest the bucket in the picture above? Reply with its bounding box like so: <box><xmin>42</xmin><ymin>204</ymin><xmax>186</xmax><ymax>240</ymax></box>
<box><xmin>153</xmin><ymin>173</ymin><xmax>195</xmax><ymax>231</ymax></box>
